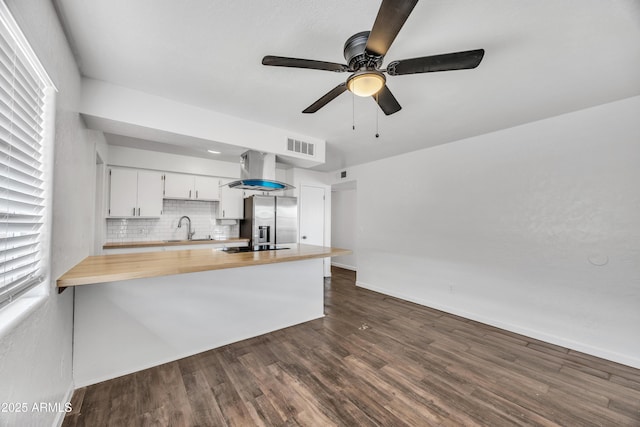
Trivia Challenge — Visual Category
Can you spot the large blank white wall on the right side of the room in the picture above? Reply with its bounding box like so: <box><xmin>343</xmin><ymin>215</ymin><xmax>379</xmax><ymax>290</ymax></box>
<box><xmin>332</xmin><ymin>97</ymin><xmax>640</xmax><ymax>368</ymax></box>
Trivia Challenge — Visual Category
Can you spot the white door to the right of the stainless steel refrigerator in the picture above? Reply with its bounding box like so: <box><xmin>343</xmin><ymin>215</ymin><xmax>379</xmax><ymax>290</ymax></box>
<box><xmin>299</xmin><ymin>185</ymin><xmax>324</xmax><ymax>246</ymax></box>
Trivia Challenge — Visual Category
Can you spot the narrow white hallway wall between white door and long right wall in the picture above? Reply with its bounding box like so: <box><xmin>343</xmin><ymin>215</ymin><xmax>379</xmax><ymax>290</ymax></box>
<box><xmin>331</xmin><ymin>189</ymin><xmax>358</xmax><ymax>270</ymax></box>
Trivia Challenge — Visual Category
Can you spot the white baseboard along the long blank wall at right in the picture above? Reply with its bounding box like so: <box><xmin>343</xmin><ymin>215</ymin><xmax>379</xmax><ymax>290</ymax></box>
<box><xmin>356</xmin><ymin>280</ymin><xmax>640</xmax><ymax>369</ymax></box>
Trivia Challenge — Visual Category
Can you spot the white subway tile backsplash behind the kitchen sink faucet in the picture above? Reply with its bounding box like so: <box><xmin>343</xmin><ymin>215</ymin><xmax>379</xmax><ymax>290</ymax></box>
<box><xmin>107</xmin><ymin>200</ymin><xmax>240</xmax><ymax>243</ymax></box>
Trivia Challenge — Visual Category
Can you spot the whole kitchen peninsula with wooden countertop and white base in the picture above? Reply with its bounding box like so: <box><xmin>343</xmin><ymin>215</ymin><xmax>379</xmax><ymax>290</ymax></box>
<box><xmin>58</xmin><ymin>245</ymin><xmax>350</xmax><ymax>387</ymax></box>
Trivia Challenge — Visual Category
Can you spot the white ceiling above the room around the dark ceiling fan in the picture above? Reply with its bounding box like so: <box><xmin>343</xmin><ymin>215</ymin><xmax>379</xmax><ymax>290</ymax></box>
<box><xmin>54</xmin><ymin>0</ymin><xmax>640</xmax><ymax>170</ymax></box>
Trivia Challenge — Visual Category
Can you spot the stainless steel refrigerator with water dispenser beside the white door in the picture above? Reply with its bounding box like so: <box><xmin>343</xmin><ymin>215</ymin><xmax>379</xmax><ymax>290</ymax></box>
<box><xmin>240</xmin><ymin>196</ymin><xmax>298</xmax><ymax>249</ymax></box>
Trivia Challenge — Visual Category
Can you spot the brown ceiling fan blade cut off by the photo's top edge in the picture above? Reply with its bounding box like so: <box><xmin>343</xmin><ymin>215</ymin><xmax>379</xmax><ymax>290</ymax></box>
<box><xmin>366</xmin><ymin>0</ymin><xmax>418</xmax><ymax>56</ymax></box>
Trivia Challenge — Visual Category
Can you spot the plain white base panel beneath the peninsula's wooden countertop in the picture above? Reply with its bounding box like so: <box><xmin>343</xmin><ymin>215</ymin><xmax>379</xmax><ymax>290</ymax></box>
<box><xmin>73</xmin><ymin>258</ymin><xmax>324</xmax><ymax>387</ymax></box>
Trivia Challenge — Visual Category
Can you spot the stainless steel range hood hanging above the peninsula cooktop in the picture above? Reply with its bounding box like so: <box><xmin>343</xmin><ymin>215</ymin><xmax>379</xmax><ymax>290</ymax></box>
<box><xmin>227</xmin><ymin>150</ymin><xmax>295</xmax><ymax>191</ymax></box>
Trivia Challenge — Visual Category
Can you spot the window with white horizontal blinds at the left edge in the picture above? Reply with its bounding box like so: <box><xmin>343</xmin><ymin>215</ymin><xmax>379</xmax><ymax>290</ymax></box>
<box><xmin>0</xmin><ymin>1</ymin><xmax>54</xmax><ymax>306</ymax></box>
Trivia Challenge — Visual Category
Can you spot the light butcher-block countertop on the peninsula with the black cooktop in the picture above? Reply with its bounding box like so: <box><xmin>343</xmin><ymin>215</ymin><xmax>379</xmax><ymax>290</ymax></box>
<box><xmin>57</xmin><ymin>245</ymin><xmax>351</xmax><ymax>288</ymax></box>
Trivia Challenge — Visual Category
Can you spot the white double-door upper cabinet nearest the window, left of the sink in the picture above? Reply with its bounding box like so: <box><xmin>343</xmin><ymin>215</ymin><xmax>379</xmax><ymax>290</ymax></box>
<box><xmin>109</xmin><ymin>168</ymin><xmax>162</xmax><ymax>218</ymax></box>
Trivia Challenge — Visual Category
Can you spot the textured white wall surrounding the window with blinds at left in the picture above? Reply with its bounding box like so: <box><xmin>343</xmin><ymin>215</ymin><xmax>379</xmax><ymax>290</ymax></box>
<box><xmin>0</xmin><ymin>0</ymin><xmax>103</xmax><ymax>426</ymax></box>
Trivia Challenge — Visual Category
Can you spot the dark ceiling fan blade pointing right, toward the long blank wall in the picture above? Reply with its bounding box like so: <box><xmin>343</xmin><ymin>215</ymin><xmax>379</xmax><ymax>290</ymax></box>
<box><xmin>387</xmin><ymin>49</ymin><xmax>484</xmax><ymax>76</ymax></box>
